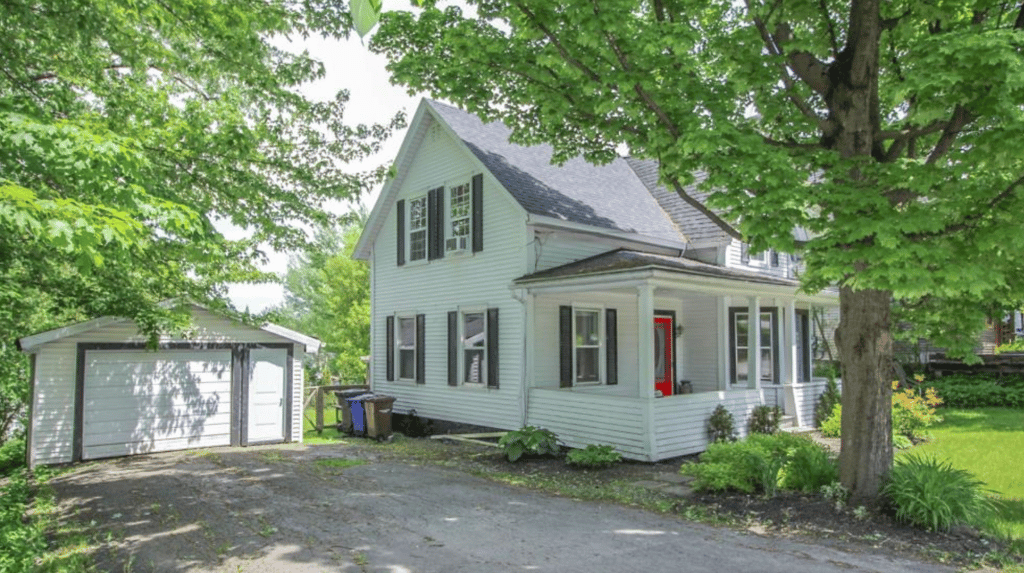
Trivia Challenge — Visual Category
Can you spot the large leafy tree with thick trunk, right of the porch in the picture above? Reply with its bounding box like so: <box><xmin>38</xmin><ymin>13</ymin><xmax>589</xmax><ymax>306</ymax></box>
<box><xmin>371</xmin><ymin>0</ymin><xmax>1024</xmax><ymax>497</ymax></box>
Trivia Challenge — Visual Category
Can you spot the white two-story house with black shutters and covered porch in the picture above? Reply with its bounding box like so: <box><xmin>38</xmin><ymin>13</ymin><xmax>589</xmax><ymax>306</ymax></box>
<box><xmin>354</xmin><ymin>100</ymin><xmax>838</xmax><ymax>460</ymax></box>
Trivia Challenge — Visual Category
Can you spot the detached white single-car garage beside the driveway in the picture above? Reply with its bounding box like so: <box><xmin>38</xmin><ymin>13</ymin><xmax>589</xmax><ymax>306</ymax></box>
<box><xmin>18</xmin><ymin>306</ymin><xmax>321</xmax><ymax>466</ymax></box>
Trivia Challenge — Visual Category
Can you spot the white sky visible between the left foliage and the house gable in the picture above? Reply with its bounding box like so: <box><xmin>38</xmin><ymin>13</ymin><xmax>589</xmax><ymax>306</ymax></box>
<box><xmin>221</xmin><ymin>34</ymin><xmax>420</xmax><ymax>312</ymax></box>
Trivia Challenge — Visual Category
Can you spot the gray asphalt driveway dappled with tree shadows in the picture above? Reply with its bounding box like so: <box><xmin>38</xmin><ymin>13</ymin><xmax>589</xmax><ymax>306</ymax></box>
<box><xmin>51</xmin><ymin>445</ymin><xmax>953</xmax><ymax>573</ymax></box>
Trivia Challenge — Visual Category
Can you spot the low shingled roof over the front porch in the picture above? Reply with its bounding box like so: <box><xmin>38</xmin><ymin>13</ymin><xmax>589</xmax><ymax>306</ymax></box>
<box><xmin>515</xmin><ymin>249</ymin><xmax>800</xmax><ymax>289</ymax></box>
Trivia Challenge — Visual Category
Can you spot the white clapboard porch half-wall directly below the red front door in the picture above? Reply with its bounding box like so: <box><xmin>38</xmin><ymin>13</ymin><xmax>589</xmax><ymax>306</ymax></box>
<box><xmin>653</xmin><ymin>390</ymin><xmax>763</xmax><ymax>459</ymax></box>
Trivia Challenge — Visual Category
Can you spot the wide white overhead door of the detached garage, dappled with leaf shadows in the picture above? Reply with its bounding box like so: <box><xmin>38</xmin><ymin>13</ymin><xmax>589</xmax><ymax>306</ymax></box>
<box><xmin>82</xmin><ymin>350</ymin><xmax>231</xmax><ymax>459</ymax></box>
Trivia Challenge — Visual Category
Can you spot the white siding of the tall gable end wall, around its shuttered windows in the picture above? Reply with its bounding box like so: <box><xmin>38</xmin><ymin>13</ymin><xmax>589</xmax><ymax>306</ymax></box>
<box><xmin>371</xmin><ymin>124</ymin><xmax>529</xmax><ymax>429</ymax></box>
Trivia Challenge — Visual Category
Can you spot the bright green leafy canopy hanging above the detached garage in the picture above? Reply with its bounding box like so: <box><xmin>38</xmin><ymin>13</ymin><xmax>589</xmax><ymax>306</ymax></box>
<box><xmin>0</xmin><ymin>0</ymin><xmax>402</xmax><ymax>337</ymax></box>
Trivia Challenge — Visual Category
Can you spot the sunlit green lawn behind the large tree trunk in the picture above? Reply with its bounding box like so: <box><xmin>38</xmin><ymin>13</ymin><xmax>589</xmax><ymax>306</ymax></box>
<box><xmin>904</xmin><ymin>408</ymin><xmax>1024</xmax><ymax>547</ymax></box>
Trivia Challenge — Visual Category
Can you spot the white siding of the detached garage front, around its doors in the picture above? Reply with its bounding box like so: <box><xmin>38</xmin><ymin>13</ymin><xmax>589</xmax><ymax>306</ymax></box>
<box><xmin>30</xmin><ymin>308</ymin><xmax>303</xmax><ymax>465</ymax></box>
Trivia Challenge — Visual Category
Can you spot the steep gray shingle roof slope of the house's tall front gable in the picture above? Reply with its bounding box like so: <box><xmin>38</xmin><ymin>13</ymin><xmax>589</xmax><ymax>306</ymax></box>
<box><xmin>428</xmin><ymin>100</ymin><xmax>685</xmax><ymax>241</ymax></box>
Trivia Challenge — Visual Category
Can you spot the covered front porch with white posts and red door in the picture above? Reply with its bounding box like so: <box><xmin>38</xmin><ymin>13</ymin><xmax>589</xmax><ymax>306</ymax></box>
<box><xmin>517</xmin><ymin>252</ymin><xmax>837</xmax><ymax>460</ymax></box>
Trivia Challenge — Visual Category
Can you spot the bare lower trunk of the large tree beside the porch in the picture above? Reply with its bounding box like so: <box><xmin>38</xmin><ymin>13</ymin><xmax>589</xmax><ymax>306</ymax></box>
<box><xmin>836</xmin><ymin>288</ymin><xmax>893</xmax><ymax>504</ymax></box>
